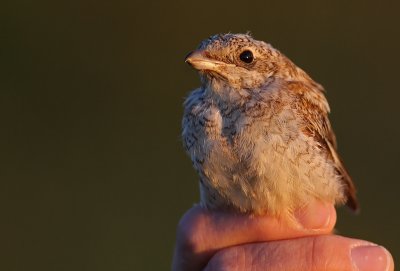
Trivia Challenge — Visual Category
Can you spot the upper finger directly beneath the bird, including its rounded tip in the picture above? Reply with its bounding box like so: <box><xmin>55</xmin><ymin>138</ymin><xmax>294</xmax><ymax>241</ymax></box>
<box><xmin>173</xmin><ymin>201</ymin><xmax>336</xmax><ymax>271</ymax></box>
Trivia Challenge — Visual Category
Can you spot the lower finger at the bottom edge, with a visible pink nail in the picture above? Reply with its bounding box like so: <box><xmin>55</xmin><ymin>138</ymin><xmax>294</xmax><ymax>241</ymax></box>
<box><xmin>205</xmin><ymin>235</ymin><xmax>394</xmax><ymax>271</ymax></box>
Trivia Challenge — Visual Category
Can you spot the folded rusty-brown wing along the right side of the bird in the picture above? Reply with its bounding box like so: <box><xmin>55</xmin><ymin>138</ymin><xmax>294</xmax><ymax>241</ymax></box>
<box><xmin>290</xmin><ymin>83</ymin><xmax>359</xmax><ymax>214</ymax></box>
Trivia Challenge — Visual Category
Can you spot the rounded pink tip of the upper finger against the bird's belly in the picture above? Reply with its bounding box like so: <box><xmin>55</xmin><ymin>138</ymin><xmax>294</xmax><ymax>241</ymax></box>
<box><xmin>295</xmin><ymin>201</ymin><xmax>335</xmax><ymax>230</ymax></box>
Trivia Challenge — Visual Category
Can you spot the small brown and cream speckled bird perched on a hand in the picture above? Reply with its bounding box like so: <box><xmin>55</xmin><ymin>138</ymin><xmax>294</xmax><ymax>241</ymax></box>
<box><xmin>182</xmin><ymin>33</ymin><xmax>359</xmax><ymax>219</ymax></box>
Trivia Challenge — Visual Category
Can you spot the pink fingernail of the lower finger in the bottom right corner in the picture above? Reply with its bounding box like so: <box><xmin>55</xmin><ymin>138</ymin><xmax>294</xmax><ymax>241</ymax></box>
<box><xmin>351</xmin><ymin>246</ymin><xmax>391</xmax><ymax>271</ymax></box>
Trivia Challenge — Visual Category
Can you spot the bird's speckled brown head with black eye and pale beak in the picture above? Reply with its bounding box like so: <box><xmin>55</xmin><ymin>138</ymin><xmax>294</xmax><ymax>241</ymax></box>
<box><xmin>185</xmin><ymin>34</ymin><xmax>296</xmax><ymax>96</ymax></box>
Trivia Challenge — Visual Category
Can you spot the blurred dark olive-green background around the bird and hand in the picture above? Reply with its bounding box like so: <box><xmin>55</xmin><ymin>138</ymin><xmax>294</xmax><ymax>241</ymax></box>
<box><xmin>0</xmin><ymin>0</ymin><xmax>400</xmax><ymax>271</ymax></box>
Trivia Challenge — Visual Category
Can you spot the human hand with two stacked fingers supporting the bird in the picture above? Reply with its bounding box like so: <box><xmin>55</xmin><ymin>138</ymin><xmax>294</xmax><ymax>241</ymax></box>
<box><xmin>172</xmin><ymin>201</ymin><xmax>394</xmax><ymax>271</ymax></box>
